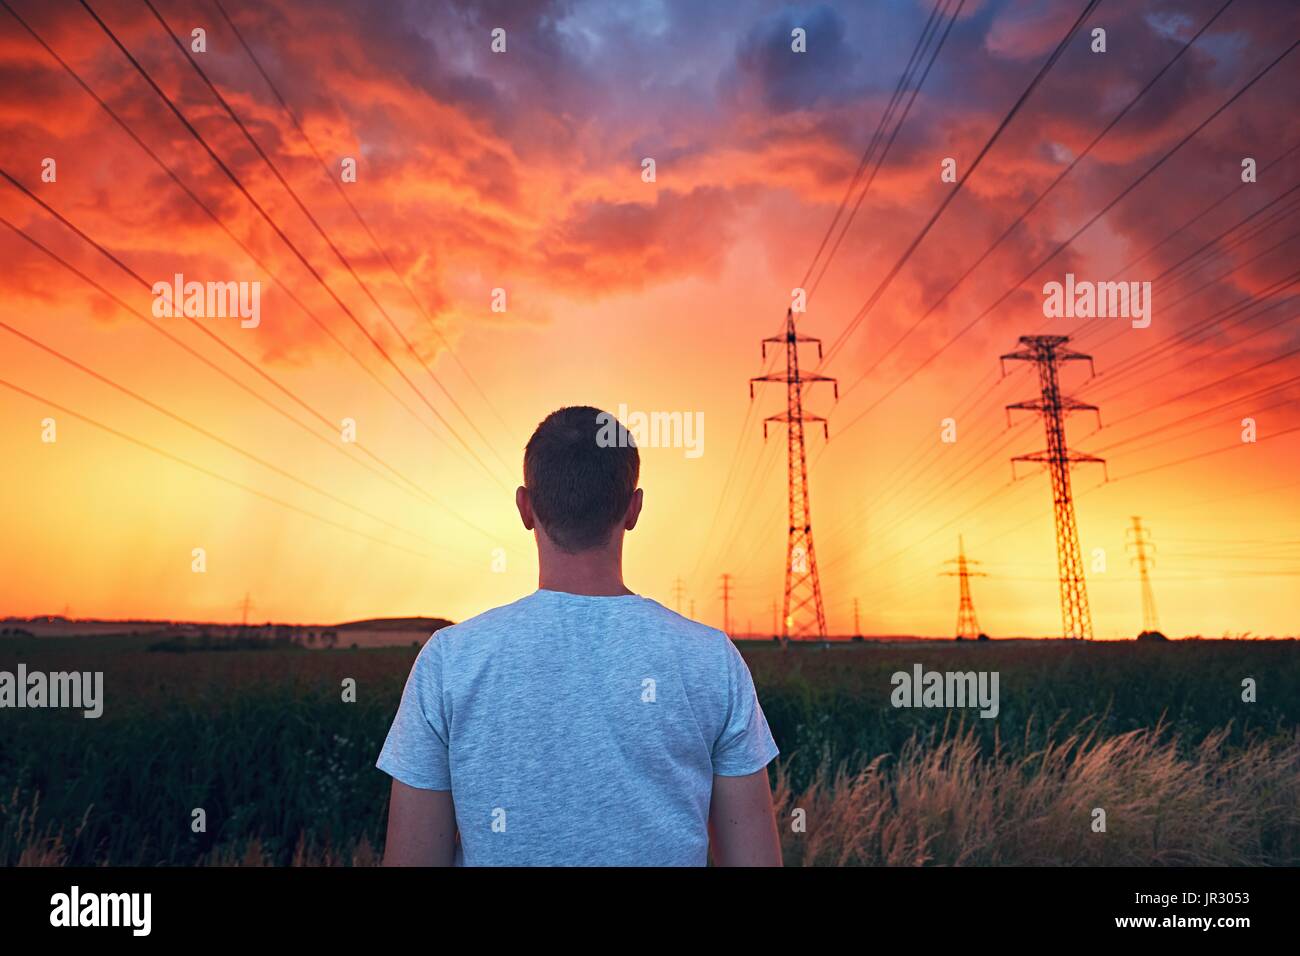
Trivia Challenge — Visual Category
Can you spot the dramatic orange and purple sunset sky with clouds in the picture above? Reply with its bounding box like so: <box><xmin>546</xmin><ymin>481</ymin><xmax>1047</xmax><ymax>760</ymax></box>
<box><xmin>0</xmin><ymin>0</ymin><xmax>1300</xmax><ymax>637</ymax></box>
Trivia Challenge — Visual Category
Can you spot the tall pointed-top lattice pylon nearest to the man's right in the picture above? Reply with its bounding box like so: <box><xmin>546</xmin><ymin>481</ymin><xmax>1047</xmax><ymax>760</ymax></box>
<box><xmin>749</xmin><ymin>310</ymin><xmax>840</xmax><ymax>639</ymax></box>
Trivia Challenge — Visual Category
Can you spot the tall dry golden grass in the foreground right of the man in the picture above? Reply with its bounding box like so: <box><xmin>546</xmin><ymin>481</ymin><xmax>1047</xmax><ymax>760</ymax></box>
<box><xmin>774</xmin><ymin>727</ymin><xmax>1300</xmax><ymax>866</ymax></box>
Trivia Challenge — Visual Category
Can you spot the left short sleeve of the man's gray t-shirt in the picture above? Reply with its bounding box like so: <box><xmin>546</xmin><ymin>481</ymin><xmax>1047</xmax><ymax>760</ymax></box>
<box><xmin>374</xmin><ymin>635</ymin><xmax>451</xmax><ymax>790</ymax></box>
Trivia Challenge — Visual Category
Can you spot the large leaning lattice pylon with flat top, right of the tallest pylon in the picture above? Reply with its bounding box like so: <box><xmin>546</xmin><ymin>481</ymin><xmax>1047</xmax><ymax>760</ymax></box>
<box><xmin>1001</xmin><ymin>336</ymin><xmax>1105</xmax><ymax>640</ymax></box>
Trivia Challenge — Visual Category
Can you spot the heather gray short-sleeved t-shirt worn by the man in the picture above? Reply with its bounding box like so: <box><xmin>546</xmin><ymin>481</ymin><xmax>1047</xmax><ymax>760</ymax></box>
<box><xmin>377</xmin><ymin>591</ymin><xmax>777</xmax><ymax>866</ymax></box>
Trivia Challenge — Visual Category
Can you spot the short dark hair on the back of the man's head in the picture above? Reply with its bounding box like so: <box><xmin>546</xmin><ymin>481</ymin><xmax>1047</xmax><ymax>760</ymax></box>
<box><xmin>524</xmin><ymin>405</ymin><xmax>641</xmax><ymax>554</ymax></box>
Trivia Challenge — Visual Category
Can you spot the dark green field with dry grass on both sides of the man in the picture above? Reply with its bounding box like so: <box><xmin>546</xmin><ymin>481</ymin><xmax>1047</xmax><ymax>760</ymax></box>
<box><xmin>0</xmin><ymin>636</ymin><xmax>1300</xmax><ymax>865</ymax></box>
